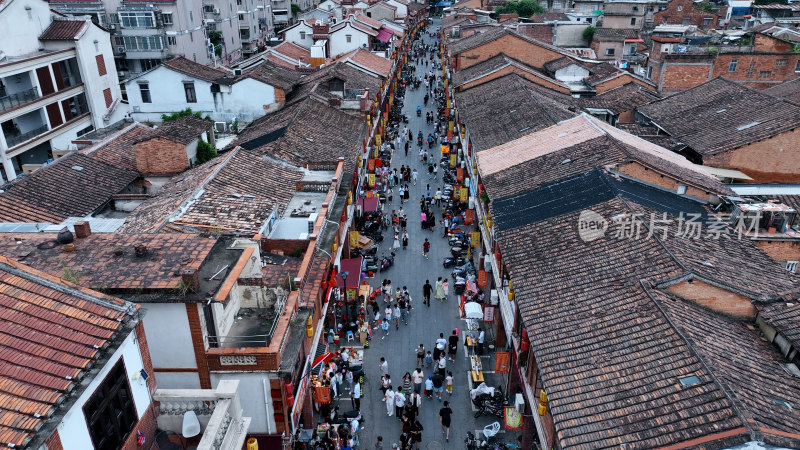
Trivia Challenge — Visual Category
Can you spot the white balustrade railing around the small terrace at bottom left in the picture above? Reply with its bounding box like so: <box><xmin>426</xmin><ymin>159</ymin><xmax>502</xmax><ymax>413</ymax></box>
<box><xmin>153</xmin><ymin>380</ymin><xmax>250</xmax><ymax>450</ymax></box>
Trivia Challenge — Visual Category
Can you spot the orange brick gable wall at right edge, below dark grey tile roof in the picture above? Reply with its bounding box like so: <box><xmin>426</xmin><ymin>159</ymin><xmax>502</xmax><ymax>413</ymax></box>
<box><xmin>703</xmin><ymin>129</ymin><xmax>800</xmax><ymax>183</ymax></box>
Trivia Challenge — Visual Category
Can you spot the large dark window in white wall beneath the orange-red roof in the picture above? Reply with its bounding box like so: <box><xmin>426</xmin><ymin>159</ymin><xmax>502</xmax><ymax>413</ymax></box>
<box><xmin>83</xmin><ymin>359</ymin><xmax>137</xmax><ymax>449</ymax></box>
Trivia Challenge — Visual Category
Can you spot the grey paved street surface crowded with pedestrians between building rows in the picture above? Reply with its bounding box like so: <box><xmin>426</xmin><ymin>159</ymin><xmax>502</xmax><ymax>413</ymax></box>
<box><xmin>318</xmin><ymin>19</ymin><xmax>512</xmax><ymax>449</ymax></box>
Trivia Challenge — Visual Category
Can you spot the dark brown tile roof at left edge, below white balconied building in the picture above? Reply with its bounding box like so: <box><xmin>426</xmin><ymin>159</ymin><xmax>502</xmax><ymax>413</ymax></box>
<box><xmin>0</xmin><ymin>153</ymin><xmax>139</xmax><ymax>222</ymax></box>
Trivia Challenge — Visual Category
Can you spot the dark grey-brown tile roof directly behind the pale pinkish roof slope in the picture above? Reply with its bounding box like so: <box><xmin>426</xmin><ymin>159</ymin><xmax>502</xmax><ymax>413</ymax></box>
<box><xmin>456</xmin><ymin>73</ymin><xmax>577</xmax><ymax>151</ymax></box>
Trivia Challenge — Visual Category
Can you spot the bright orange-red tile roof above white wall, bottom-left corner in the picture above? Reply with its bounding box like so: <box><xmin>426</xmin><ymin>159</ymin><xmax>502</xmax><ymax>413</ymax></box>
<box><xmin>0</xmin><ymin>256</ymin><xmax>136</xmax><ymax>448</ymax></box>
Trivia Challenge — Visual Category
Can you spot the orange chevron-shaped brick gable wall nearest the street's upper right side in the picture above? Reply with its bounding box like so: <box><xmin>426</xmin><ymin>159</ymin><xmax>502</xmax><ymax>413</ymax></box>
<box><xmin>454</xmin><ymin>35</ymin><xmax>563</xmax><ymax>70</ymax></box>
